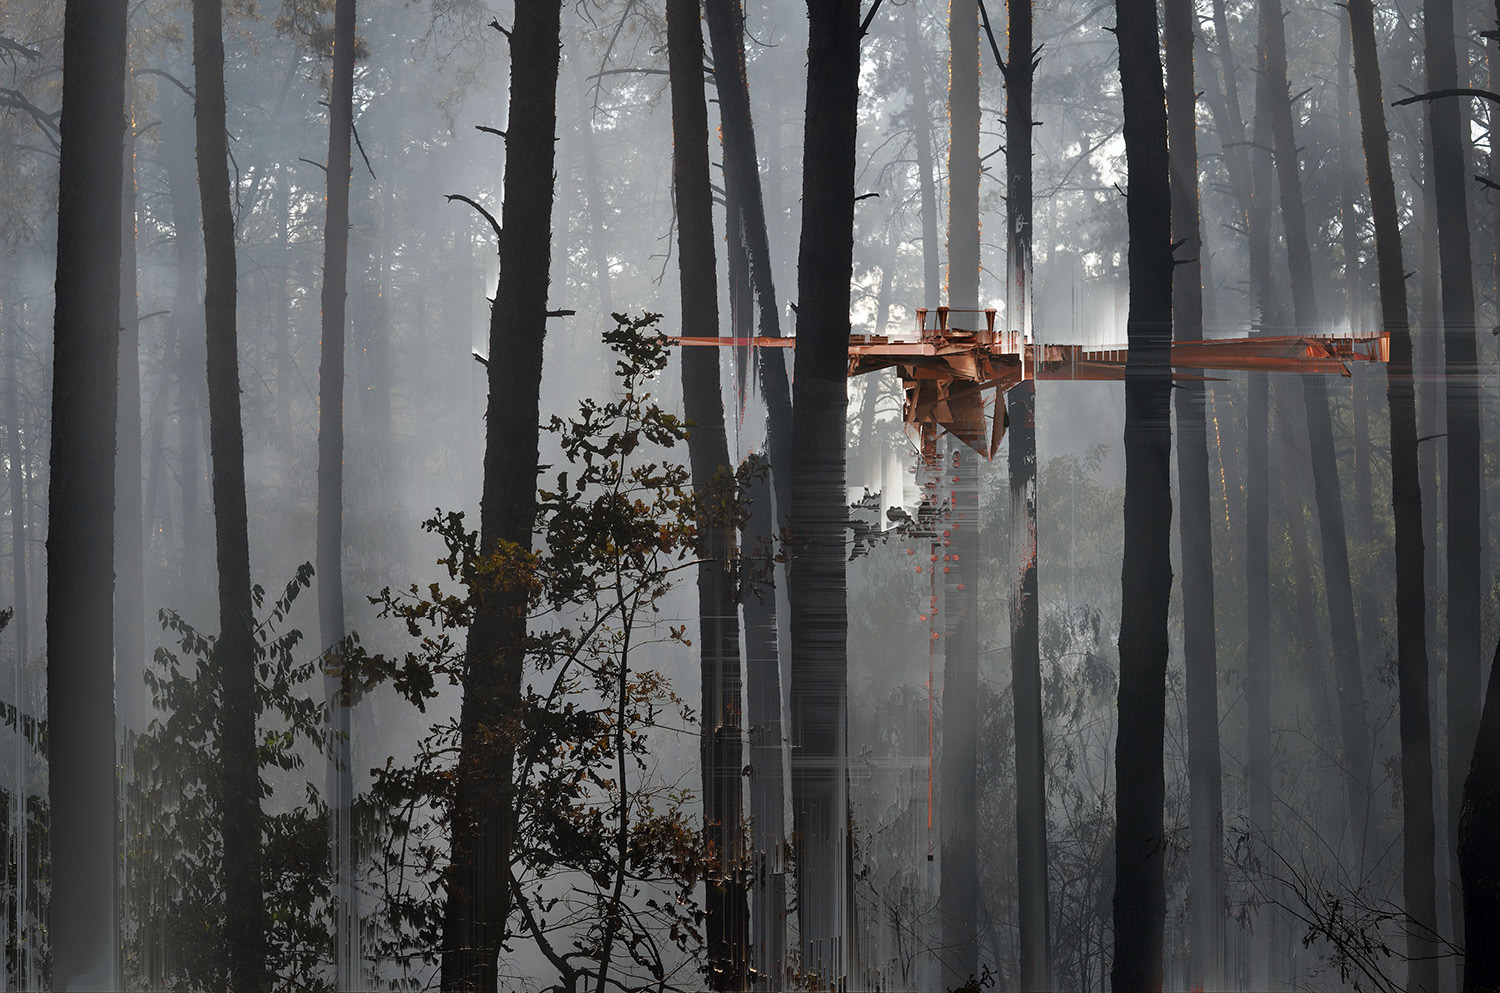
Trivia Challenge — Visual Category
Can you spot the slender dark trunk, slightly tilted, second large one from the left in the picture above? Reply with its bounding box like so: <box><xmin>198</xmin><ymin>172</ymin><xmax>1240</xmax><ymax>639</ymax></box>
<box><xmin>192</xmin><ymin>0</ymin><xmax>269</xmax><ymax>993</ymax></box>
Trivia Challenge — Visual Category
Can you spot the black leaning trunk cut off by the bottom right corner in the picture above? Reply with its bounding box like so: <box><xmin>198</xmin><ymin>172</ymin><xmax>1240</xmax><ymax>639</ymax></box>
<box><xmin>1458</xmin><ymin>645</ymin><xmax>1500</xmax><ymax>993</ymax></box>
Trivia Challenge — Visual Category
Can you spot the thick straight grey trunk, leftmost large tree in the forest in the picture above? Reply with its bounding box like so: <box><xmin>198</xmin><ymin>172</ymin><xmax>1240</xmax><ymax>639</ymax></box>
<box><xmin>48</xmin><ymin>0</ymin><xmax>126</xmax><ymax>990</ymax></box>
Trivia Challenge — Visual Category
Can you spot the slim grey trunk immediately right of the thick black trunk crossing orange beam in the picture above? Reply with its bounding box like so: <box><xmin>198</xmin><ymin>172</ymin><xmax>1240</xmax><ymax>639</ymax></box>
<box><xmin>1163</xmin><ymin>0</ymin><xmax>1226</xmax><ymax>990</ymax></box>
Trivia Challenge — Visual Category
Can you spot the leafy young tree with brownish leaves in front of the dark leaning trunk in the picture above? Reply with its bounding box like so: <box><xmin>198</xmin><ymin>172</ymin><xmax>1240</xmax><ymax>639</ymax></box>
<box><xmin>344</xmin><ymin>315</ymin><xmax>741</xmax><ymax>990</ymax></box>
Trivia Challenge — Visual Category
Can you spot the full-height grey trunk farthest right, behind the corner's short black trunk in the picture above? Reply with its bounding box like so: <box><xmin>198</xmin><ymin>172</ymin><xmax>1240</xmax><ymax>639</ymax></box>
<box><xmin>1422</xmin><ymin>0</ymin><xmax>1485</xmax><ymax>966</ymax></box>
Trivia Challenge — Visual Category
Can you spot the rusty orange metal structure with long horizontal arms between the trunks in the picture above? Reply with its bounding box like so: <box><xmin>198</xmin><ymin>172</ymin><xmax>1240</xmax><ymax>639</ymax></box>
<box><xmin>675</xmin><ymin>308</ymin><xmax>1391</xmax><ymax>458</ymax></box>
